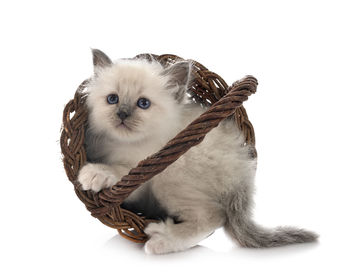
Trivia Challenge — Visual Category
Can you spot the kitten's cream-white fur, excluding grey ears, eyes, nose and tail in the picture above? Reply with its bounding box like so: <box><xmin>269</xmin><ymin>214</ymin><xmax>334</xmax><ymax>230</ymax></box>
<box><xmin>78</xmin><ymin>56</ymin><xmax>255</xmax><ymax>254</ymax></box>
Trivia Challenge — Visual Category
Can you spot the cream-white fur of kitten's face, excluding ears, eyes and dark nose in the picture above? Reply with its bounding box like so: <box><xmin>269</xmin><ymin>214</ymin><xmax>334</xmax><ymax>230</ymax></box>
<box><xmin>87</xmin><ymin>60</ymin><xmax>180</xmax><ymax>147</ymax></box>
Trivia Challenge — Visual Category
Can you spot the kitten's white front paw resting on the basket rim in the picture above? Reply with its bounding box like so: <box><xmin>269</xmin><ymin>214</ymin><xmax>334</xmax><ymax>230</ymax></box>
<box><xmin>78</xmin><ymin>163</ymin><xmax>118</xmax><ymax>192</ymax></box>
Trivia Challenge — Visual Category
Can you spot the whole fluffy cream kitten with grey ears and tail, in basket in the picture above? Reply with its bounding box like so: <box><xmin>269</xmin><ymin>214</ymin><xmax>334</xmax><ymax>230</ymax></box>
<box><xmin>78</xmin><ymin>50</ymin><xmax>317</xmax><ymax>254</ymax></box>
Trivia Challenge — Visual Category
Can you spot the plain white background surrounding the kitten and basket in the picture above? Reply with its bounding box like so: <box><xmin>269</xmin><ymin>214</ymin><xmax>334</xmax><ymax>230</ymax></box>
<box><xmin>0</xmin><ymin>0</ymin><xmax>350</xmax><ymax>277</ymax></box>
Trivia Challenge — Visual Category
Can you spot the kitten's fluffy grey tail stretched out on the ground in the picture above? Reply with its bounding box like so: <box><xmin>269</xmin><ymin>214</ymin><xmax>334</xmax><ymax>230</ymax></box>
<box><xmin>225</xmin><ymin>206</ymin><xmax>318</xmax><ymax>248</ymax></box>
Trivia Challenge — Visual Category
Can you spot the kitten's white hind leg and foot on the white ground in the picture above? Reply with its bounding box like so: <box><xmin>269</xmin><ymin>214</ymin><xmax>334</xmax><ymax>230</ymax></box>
<box><xmin>145</xmin><ymin>208</ymin><xmax>225</xmax><ymax>254</ymax></box>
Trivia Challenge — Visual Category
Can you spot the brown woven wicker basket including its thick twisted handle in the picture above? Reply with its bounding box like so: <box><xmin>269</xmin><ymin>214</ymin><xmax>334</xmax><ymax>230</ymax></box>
<box><xmin>60</xmin><ymin>54</ymin><xmax>257</xmax><ymax>242</ymax></box>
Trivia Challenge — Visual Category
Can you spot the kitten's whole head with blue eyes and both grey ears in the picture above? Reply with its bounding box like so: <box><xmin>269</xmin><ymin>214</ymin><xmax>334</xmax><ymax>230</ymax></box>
<box><xmin>87</xmin><ymin>49</ymin><xmax>191</xmax><ymax>142</ymax></box>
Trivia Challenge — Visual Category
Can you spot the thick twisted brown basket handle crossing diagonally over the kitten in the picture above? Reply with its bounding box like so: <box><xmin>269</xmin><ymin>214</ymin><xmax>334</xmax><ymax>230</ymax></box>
<box><xmin>95</xmin><ymin>76</ymin><xmax>258</xmax><ymax>206</ymax></box>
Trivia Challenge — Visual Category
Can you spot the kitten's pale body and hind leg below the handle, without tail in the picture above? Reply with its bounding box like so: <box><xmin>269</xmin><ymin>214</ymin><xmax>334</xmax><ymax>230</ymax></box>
<box><xmin>145</xmin><ymin>119</ymin><xmax>256</xmax><ymax>254</ymax></box>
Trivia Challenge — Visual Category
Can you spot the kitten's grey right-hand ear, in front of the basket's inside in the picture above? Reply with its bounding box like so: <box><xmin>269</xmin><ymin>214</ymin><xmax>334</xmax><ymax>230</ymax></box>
<box><xmin>163</xmin><ymin>61</ymin><xmax>192</xmax><ymax>102</ymax></box>
